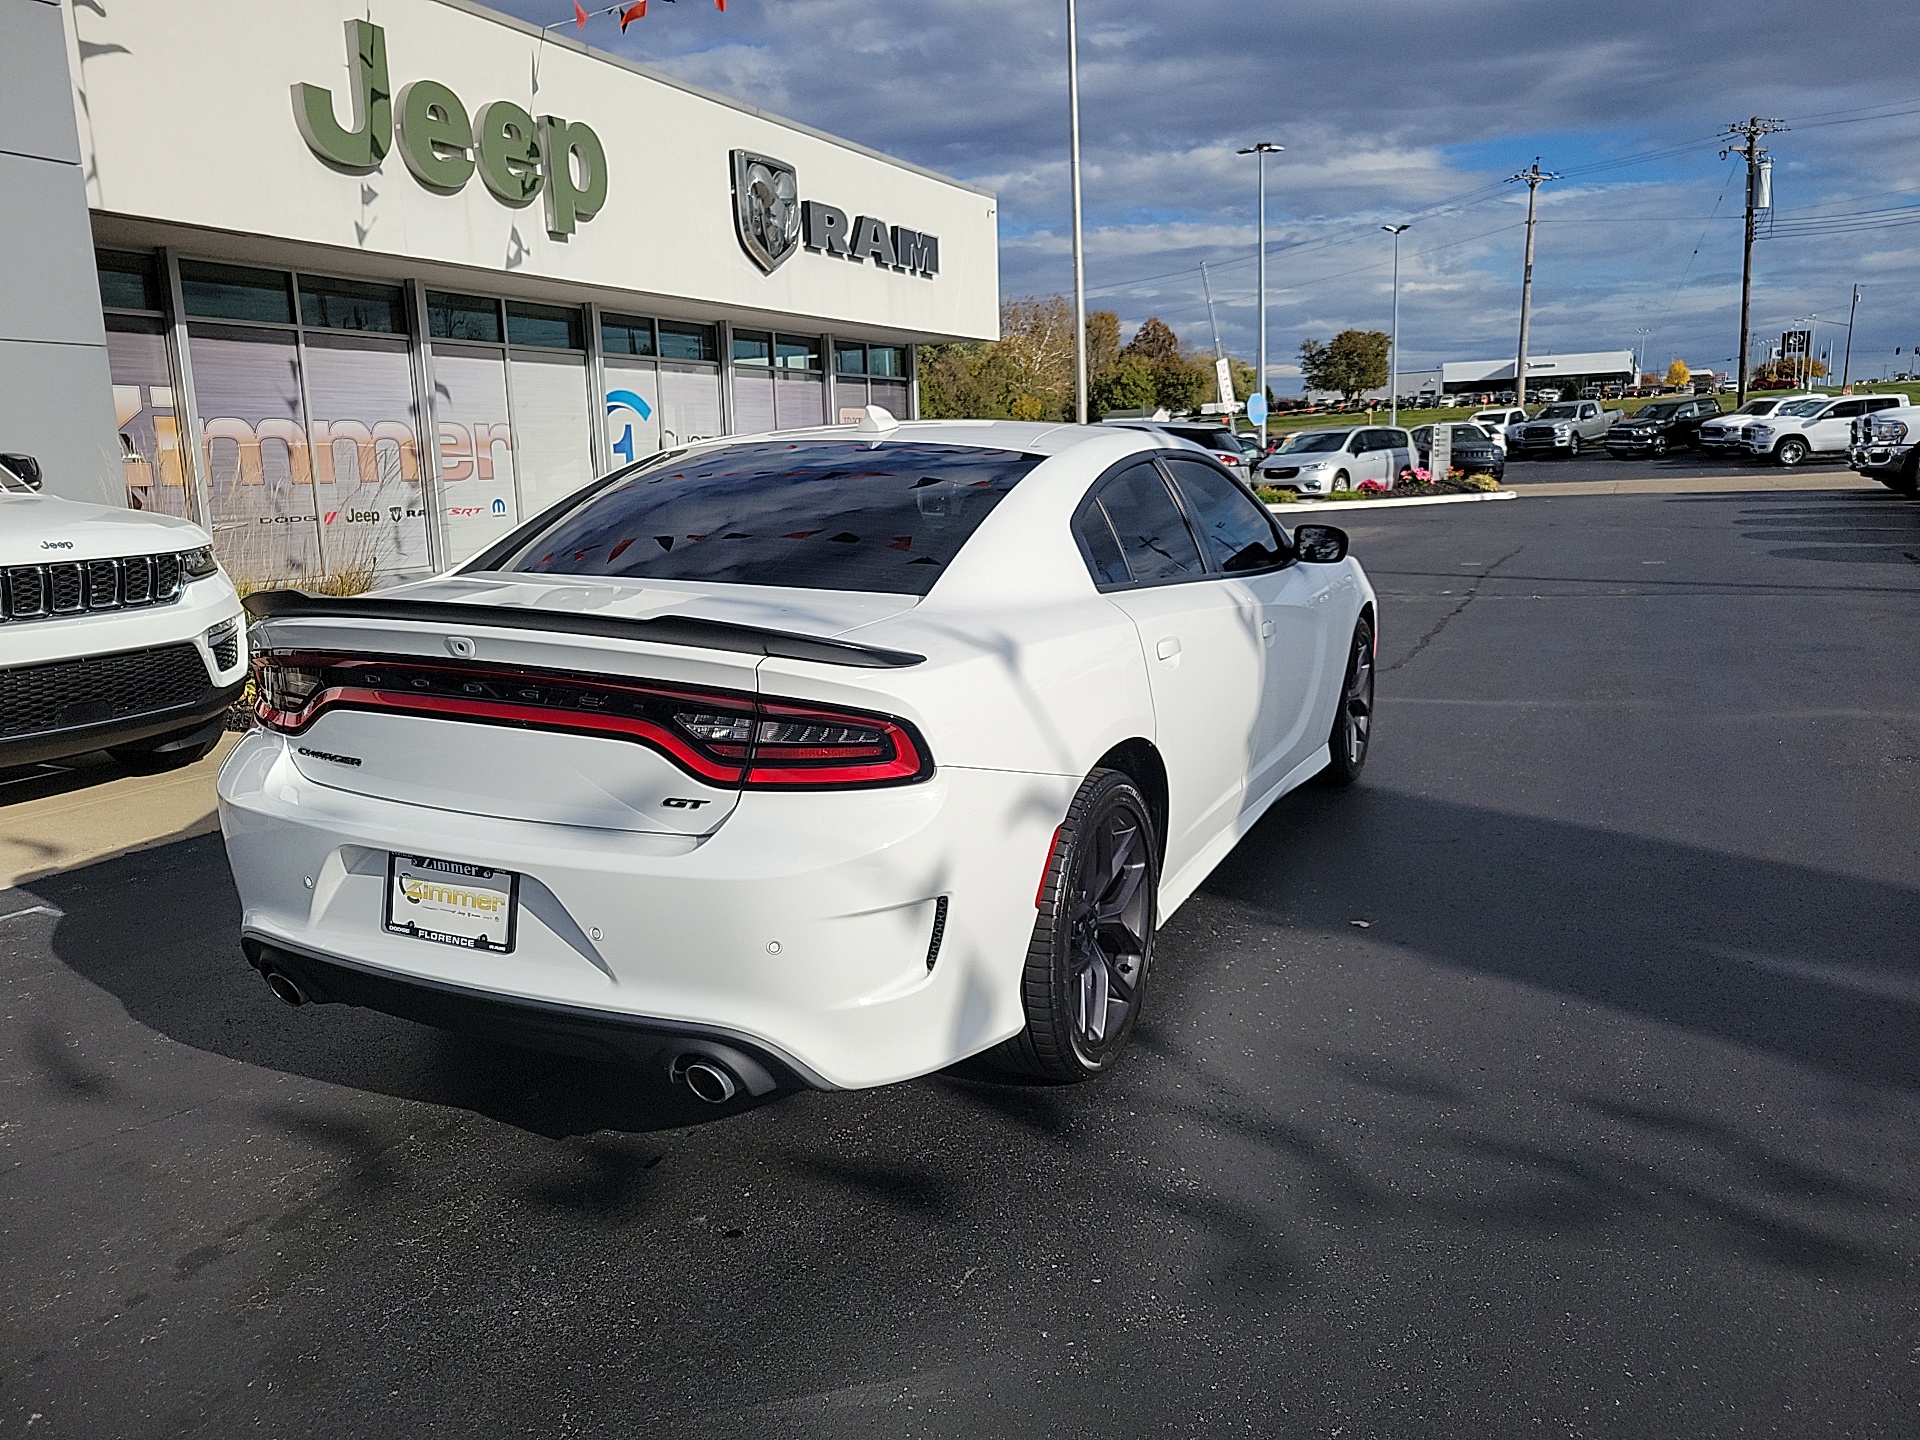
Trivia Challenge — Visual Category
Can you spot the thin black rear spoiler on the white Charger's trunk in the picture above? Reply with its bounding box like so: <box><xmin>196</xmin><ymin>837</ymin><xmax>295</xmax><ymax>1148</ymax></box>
<box><xmin>244</xmin><ymin>589</ymin><xmax>927</xmax><ymax>670</ymax></box>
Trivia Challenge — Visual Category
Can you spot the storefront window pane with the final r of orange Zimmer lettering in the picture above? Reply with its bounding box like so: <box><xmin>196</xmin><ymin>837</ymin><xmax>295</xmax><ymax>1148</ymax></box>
<box><xmin>434</xmin><ymin>346</ymin><xmax>520</xmax><ymax>564</ymax></box>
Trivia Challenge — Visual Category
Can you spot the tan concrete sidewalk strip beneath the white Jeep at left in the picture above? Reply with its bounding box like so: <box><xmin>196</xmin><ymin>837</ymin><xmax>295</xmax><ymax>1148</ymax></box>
<box><xmin>0</xmin><ymin>733</ymin><xmax>240</xmax><ymax>889</ymax></box>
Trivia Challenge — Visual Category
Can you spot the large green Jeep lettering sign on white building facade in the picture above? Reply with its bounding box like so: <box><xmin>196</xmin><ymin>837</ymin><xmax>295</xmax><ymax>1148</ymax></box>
<box><xmin>294</xmin><ymin>19</ymin><xmax>607</xmax><ymax>238</ymax></box>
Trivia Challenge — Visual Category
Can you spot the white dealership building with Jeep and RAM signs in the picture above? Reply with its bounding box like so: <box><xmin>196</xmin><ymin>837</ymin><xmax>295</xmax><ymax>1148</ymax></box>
<box><xmin>11</xmin><ymin>0</ymin><xmax>998</xmax><ymax>582</ymax></box>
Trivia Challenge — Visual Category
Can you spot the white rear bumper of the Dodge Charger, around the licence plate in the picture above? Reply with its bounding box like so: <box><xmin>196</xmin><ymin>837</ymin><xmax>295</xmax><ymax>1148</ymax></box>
<box><xmin>219</xmin><ymin>732</ymin><xmax>1077</xmax><ymax>1089</ymax></box>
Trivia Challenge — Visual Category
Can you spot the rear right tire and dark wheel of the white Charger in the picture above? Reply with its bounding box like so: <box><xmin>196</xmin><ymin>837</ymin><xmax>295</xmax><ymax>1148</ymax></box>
<box><xmin>991</xmin><ymin>770</ymin><xmax>1160</xmax><ymax>1083</ymax></box>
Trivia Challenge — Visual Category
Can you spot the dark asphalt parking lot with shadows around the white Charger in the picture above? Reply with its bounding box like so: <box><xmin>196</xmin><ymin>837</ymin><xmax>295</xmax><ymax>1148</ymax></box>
<box><xmin>0</xmin><ymin>480</ymin><xmax>1920</xmax><ymax>1438</ymax></box>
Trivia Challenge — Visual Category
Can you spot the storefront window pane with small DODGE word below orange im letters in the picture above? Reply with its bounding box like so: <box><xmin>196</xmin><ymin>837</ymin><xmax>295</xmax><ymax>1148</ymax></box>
<box><xmin>188</xmin><ymin>324</ymin><xmax>324</xmax><ymax>584</ymax></box>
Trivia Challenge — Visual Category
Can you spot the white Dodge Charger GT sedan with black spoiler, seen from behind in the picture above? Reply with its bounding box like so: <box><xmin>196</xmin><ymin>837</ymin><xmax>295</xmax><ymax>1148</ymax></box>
<box><xmin>219</xmin><ymin>411</ymin><xmax>1375</xmax><ymax>1100</ymax></box>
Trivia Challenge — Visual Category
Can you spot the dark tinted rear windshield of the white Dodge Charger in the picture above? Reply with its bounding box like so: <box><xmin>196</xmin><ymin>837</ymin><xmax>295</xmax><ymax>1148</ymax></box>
<box><xmin>493</xmin><ymin>442</ymin><xmax>1046</xmax><ymax>595</ymax></box>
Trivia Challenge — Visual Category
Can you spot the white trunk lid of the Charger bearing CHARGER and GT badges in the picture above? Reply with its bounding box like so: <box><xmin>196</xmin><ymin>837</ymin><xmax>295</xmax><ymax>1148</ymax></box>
<box><xmin>255</xmin><ymin>576</ymin><xmax>916</xmax><ymax>835</ymax></box>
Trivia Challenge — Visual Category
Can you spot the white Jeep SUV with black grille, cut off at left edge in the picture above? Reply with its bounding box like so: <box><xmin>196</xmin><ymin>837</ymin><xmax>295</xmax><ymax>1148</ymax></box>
<box><xmin>0</xmin><ymin>455</ymin><xmax>246</xmax><ymax>770</ymax></box>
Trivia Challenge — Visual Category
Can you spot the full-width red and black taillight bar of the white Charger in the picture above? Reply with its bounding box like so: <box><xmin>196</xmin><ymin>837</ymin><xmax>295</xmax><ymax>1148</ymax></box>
<box><xmin>253</xmin><ymin>651</ymin><xmax>933</xmax><ymax>789</ymax></box>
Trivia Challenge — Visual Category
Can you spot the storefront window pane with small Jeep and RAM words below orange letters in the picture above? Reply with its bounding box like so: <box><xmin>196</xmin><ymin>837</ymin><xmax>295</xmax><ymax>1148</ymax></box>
<box><xmin>301</xmin><ymin>336</ymin><xmax>430</xmax><ymax>574</ymax></box>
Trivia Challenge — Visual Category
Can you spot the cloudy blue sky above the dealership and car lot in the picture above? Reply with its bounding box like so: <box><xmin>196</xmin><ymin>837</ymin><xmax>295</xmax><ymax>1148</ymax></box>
<box><xmin>497</xmin><ymin>0</ymin><xmax>1920</xmax><ymax>390</ymax></box>
